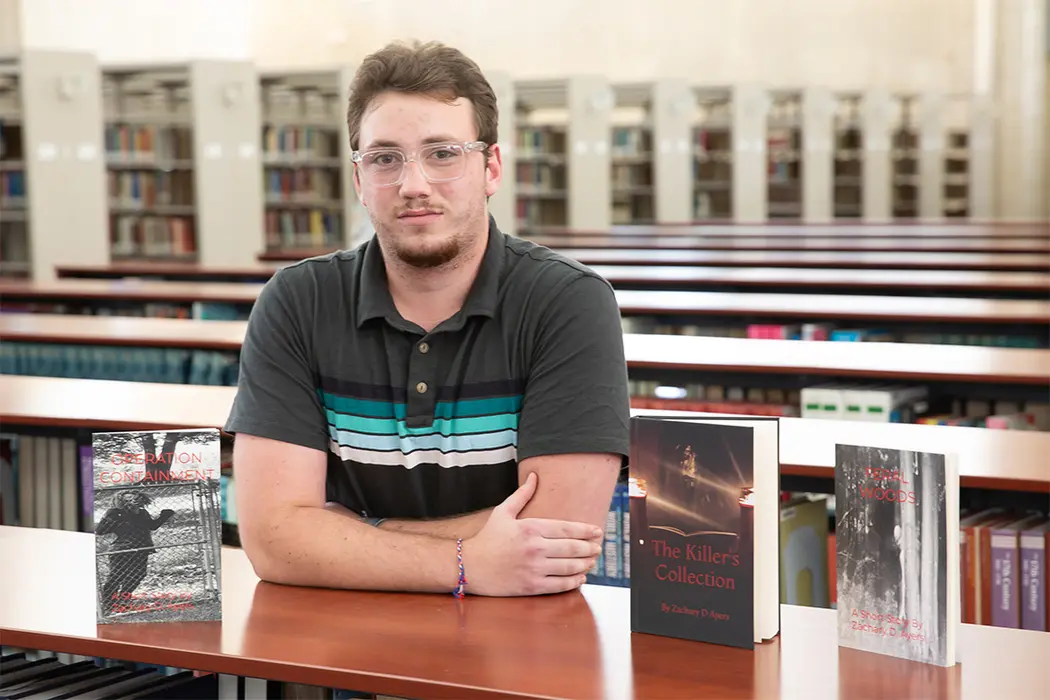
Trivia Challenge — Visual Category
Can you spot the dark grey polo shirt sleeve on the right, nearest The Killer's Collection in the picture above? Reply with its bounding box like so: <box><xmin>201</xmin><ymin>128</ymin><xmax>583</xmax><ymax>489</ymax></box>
<box><xmin>518</xmin><ymin>274</ymin><xmax>630</xmax><ymax>465</ymax></box>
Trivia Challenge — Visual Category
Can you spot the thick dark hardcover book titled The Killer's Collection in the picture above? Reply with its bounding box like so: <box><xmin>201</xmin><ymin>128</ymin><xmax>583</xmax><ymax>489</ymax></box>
<box><xmin>627</xmin><ymin>416</ymin><xmax>780</xmax><ymax>649</ymax></box>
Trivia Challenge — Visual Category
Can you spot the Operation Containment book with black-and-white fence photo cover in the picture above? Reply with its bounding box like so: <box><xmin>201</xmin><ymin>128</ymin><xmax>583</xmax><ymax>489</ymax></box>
<box><xmin>92</xmin><ymin>429</ymin><xmax>223</xmax><ymax>623</ymax></box>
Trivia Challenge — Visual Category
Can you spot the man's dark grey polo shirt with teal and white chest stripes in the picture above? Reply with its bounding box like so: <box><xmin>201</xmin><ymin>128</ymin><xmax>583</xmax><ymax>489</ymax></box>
<box><xmin>225</xmin><ymin>217</ymin><xmax>630</xmax><ymax>518</ymax></box>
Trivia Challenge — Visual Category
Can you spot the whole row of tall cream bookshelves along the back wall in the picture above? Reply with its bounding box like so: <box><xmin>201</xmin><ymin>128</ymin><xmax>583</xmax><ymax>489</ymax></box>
<box><xmin>0</xmin><ymin>49</ymin><xmax>1034</xmax><ymax>279</ymax></box>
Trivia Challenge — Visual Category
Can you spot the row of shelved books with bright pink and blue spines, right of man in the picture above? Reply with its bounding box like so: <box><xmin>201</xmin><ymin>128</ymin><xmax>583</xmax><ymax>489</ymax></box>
<box><xmin>622</xmin><ymin>316</ymin><xmax>1050</xmax><ymax>348</ymax></box>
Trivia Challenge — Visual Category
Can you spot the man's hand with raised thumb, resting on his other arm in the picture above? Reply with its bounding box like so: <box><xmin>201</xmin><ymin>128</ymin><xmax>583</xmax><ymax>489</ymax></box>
<box><xmin>463</xmin><ymin>473</ymin><xmax>604</xmax><ymax>596</ymax></box>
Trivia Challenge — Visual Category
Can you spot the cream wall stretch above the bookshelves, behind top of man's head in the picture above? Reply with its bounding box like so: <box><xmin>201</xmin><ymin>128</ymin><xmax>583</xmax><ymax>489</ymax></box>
<box><xmin>249</xmin><ymin>0</ymin><xmax>973</xmax><ymax>91</ymax></box>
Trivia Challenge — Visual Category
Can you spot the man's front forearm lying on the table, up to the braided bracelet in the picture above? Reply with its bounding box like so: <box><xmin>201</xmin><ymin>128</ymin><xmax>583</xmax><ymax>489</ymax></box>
<box><xmin>243</xmin><ymin>507</ymin><xmax>459</xmax><ymax>592</ymax></box>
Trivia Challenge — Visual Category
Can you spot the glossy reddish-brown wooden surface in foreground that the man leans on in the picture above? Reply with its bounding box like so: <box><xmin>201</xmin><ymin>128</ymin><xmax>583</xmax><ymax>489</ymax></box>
<box><xmin>0</xmin><ymin>527</ymin><xmax>1050</xmax><ymax>700</ymax></box>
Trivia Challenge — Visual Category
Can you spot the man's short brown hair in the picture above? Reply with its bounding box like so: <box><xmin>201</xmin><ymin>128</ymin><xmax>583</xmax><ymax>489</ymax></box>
<box><xmin>347</xmin><ymin>41</ymin><xmax>499</xmax><ymax>150</ymax></box>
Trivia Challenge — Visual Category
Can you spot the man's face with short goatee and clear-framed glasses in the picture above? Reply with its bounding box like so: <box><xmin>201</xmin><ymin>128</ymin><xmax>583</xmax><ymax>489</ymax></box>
<box><xmin>354</xmin><ymin>92</ymin><xmax>501</xmax><ymax>268</ymax></box>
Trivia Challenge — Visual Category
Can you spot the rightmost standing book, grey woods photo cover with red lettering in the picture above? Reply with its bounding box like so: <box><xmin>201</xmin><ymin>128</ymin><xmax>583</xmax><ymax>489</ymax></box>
<box><xmin>835</xmin><ymin>444</ymin><xmax>962</xmax><ymax>666</ymax></box>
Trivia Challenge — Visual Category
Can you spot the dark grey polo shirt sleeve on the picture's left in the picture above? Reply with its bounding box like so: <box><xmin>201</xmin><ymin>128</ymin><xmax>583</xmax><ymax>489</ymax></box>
<box><xmin>224</xmin><ymin>272</ymin><xmax>329</xmax><ymax>451</ymax></box>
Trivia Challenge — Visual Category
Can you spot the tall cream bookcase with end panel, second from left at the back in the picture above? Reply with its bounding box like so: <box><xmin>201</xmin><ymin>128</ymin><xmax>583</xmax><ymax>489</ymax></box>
<box><xmin>101</xmin><ymin>61</ymin><xmax>263</xmax><ymax>264</ymax></box>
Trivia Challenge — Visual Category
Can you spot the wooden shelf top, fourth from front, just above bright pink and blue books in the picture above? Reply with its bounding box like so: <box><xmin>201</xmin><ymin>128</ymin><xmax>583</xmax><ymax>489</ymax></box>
<box><xmin>0</xmin><ymin>279</ymin><xmax>1050</xmax><ymax>324</ymax></box>
